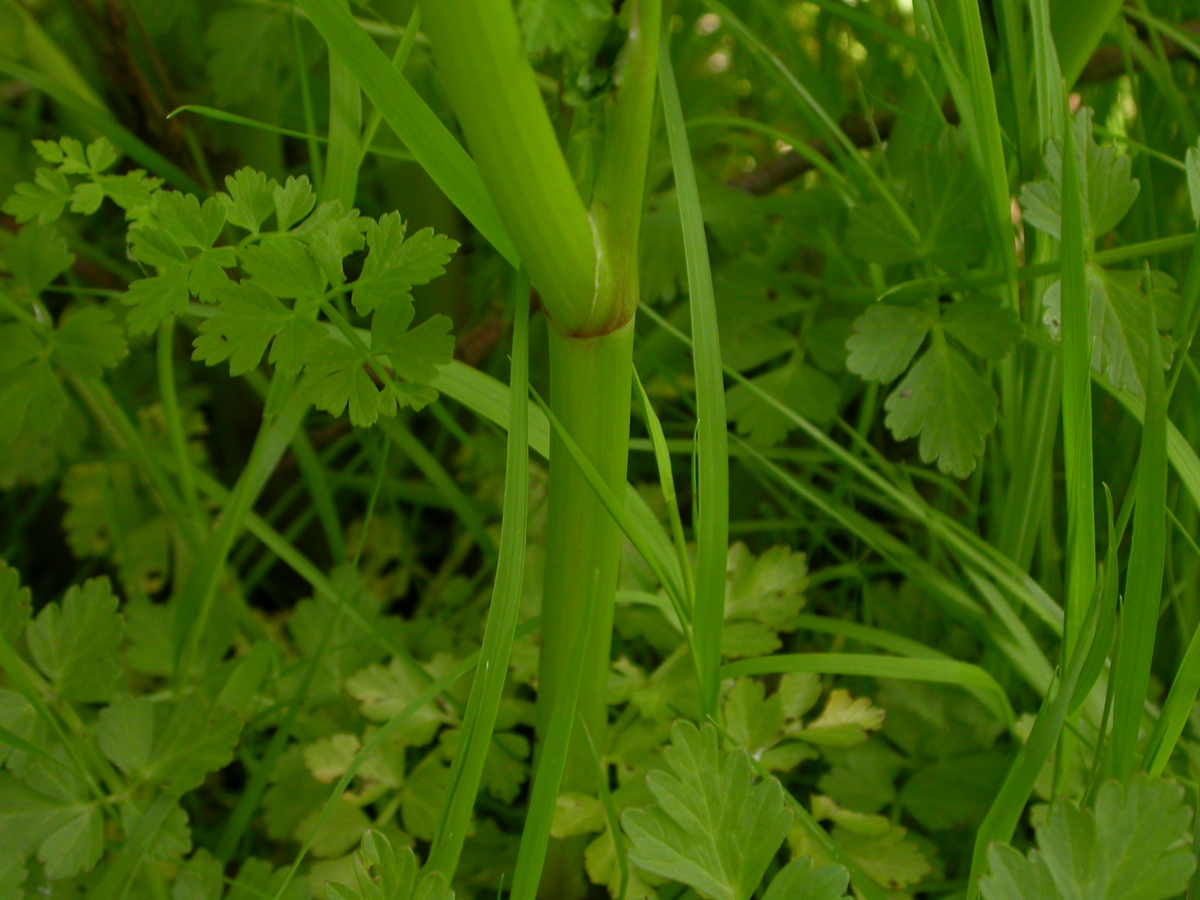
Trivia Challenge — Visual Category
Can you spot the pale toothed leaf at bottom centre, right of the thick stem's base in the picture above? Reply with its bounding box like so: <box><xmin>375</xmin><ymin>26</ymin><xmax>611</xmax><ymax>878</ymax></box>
<box><xmin>622</xmin><ymin>721</ymin><xmax>792</xmax><ymax>900</ymax></box>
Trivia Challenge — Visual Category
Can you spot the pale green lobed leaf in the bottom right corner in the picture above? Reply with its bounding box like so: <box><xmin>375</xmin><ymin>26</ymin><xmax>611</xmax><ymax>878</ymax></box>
<box><xmin>980</xmin><ymin>775</ymin><xmax>1196</xmax><ymax>900</ymax></box>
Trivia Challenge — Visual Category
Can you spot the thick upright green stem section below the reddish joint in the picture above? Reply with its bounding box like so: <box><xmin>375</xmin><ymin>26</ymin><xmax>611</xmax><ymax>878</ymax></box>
<box><xmin>538</xmin><ymin>320</ymin><xmax>634</xmax><ymax>790</ymax></box>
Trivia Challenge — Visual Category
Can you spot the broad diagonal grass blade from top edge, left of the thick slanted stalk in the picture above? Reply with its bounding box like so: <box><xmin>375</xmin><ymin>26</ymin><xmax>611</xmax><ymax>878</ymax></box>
<box><xmin>296</xmin><ymin>0</ymin><xmax>520</xmax><ymax>266</ymax></box>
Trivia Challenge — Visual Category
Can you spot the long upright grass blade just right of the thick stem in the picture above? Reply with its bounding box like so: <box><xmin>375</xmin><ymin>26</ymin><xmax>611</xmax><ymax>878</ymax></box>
<box><xmin>659</xmin><ymin>40</ymin><xmax>730</xmax><ymax>714</ymax></box>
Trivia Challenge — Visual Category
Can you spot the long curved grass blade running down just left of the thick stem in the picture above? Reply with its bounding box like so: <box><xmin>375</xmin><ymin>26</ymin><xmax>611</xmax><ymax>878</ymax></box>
<box><xmin>426</xmin><ymin>274</ymin><xmax>529</xmax><ymax>882</ymax></box>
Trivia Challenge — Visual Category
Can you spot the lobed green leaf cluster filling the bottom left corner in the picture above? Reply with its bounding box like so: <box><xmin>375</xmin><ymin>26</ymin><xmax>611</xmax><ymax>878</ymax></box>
<box><xmin>0</xmin><ymin>573</ymin><xmax>242</xmax><ymax>896</ymax></box>
